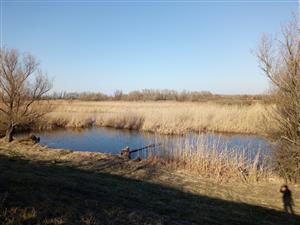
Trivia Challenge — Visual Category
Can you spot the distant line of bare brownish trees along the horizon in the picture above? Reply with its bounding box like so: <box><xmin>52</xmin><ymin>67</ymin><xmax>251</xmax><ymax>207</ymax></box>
<box><xmin>46</xmin><ymin>89</ymin><xmax>268</xmax><ymax>104</ymax></box>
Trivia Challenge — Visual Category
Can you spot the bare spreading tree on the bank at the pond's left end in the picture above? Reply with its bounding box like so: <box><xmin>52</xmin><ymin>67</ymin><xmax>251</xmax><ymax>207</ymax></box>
<box><xmin>0</xmin><ymin>48</ymin><xmax>52</xmax><ymax>141</ymax></box>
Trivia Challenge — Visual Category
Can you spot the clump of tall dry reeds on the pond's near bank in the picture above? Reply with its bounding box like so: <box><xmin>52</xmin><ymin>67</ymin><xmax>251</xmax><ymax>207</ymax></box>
<box><xmin>148</xmin><ymin>137</ymin><xmax>272</xmax><ymax>183</ymax></box>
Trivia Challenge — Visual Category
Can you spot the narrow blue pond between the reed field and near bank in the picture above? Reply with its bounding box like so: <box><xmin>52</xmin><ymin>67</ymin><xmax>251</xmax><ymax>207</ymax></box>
<box><xmin>27</xmin><ymin>128</ymin><xmax>271</xmax><ymax>159</ymax></box>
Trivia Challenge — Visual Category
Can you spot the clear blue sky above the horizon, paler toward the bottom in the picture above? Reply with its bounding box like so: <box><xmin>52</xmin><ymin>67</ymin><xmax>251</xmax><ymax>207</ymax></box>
<box><xmin>1</xmin><ymin>0</ymin><xmax>297</xmax><ymax>94</ymax></box>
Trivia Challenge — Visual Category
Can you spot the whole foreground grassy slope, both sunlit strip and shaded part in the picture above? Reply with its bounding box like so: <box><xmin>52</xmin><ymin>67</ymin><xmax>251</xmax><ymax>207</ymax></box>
<box><xmin>0</xmin><ymin>141</ymin><xmax>300</xmax><ymax>225</ymax></box>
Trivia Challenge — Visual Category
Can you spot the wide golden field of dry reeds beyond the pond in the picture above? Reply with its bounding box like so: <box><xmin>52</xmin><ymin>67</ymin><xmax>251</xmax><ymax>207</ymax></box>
<box><xmin>40</xmin><ymin>100</ymin><xmax>268</xmax><ymax>134</ymax></box>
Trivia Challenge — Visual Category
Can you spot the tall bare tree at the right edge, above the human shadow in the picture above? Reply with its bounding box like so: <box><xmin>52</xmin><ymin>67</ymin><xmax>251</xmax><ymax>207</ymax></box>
<box><xmin>257</xmin><ymin>17</ymin><xmax>300</xmax><ymax>181</ymax></box>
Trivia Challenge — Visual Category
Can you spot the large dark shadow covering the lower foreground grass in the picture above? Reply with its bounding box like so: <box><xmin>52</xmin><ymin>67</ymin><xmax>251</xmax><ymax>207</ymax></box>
<box><xmin>0</xmin><ymin>155</ymin><xmax>300</xmax><ymax>225</ymax></box>
